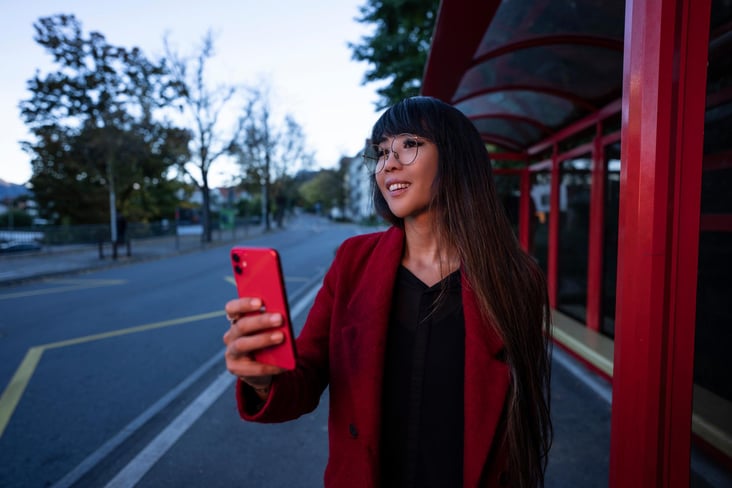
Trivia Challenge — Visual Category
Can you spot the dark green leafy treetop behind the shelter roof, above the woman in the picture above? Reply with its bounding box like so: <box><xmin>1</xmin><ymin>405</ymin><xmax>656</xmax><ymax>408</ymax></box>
<box><xmin>348</xmin><ymin>0</ymin><xmax>440</xmax><ymax>110</ymax></box>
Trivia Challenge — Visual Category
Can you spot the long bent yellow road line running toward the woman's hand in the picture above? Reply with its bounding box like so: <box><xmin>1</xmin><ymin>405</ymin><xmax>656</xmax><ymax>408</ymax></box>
<box><xmin>0</xmin><ymin>310</ymin><xmax>225</xmax><ymax>438</ymax></box>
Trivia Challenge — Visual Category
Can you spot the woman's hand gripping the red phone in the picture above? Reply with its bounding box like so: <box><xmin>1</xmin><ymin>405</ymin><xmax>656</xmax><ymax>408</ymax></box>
<box><xmin>224</xmin><ymin>298</ymin><xmax>284</xmax><ymax>399</ymax></box>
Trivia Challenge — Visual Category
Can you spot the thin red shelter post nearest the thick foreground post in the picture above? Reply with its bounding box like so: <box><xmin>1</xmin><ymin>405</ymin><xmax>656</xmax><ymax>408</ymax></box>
<box><xmin>586</xmin><ymin>122</ymin><xmax>607</xmax><ymax>330</ymax></box>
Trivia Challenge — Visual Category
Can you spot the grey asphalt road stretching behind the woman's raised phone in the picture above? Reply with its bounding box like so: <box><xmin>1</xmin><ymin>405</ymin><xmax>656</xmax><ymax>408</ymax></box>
<box><xmin>0</xmin><ymin>219</ymin><xmax>360</xmax><ymax>487</ymax></box>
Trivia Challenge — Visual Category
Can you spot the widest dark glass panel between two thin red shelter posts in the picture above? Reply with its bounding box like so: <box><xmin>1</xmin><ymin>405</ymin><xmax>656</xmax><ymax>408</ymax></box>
<box><xmin>557</xmin><ymin>154</ymin><xmax>592</xmax><ymax>322</ymax></box>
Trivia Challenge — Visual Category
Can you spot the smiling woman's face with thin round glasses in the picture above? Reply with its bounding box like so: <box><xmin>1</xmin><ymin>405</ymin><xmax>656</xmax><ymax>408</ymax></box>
<box><xmin>376</xmin><ymin>134</ymin><xmax>438</xmax><ymax>219</ymax></box>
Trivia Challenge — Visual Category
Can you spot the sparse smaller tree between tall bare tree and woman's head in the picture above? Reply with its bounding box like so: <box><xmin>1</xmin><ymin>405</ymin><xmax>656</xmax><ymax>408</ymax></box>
<box><xmin>235</xmin><ymin>90</ymin><xmax>313</xmax><ymax>230</ymax></box>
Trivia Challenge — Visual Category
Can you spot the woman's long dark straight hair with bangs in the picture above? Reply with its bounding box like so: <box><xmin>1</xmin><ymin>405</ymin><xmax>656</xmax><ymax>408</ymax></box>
<box><xmin>371</xmin><ymin>97</ymin><xmax>553</xmax><ymax>487</ymax></box>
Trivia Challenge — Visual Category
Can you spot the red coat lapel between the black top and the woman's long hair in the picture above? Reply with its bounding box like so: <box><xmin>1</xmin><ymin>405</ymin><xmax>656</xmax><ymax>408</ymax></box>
<box><xmin>462</xmin><ymin>273</ymin><xmax>510</xmax><ymax>486</ymax></box>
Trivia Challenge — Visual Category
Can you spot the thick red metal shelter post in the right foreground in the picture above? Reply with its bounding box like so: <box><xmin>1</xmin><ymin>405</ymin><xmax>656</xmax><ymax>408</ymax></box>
<box><xmin>610</xmin><ymin>0</ymin><xmax>710</xmax><ymax>487</ymax></box>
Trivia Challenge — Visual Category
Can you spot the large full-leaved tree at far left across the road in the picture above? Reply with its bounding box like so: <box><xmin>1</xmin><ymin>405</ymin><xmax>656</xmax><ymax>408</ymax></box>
<box><xmin>20</xmin><ymin>15</ymin><xmax>188</xmax><ymax>228</ymax></box>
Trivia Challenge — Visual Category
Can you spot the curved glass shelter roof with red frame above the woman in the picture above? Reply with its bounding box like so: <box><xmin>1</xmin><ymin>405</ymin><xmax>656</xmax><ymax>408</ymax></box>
<box><xmin>422</xmin><ymin>0</ymin><xmax>625</xmax><ymax>151</ymax></box>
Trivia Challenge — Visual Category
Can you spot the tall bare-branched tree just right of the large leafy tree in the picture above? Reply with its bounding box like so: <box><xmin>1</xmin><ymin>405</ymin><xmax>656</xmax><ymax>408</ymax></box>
<box><xmin>165</xmin><ymin>31</ymin><xmax>241</xmax><ymax>242</ymax></box>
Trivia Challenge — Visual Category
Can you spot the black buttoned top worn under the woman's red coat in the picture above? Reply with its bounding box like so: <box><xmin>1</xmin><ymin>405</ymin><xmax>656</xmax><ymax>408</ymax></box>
<box><xmin>381</xmin><ymin>266</ymin><xmax>465</xmax><ymax>488</ymax></box>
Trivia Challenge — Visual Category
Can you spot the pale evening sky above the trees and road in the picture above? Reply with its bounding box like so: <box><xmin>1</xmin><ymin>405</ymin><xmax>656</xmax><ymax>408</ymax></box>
<box><xmin>0</xmin><ymin>0</ymin><xmax>386</xmax><ymax>187</ymax></box>
